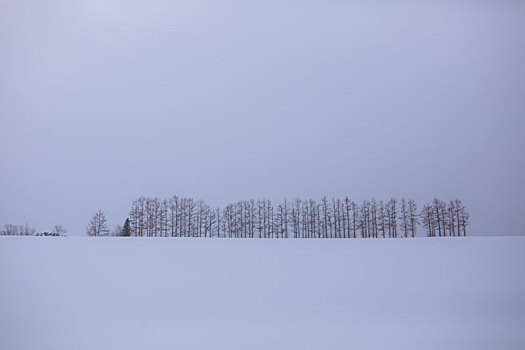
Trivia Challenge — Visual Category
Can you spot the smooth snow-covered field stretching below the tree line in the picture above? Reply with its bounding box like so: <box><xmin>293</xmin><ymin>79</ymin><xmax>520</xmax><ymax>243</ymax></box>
<box><xmin>0</xmin><ymin>237</ymin><xmax>525</xmax><ymax>350</ymax></box>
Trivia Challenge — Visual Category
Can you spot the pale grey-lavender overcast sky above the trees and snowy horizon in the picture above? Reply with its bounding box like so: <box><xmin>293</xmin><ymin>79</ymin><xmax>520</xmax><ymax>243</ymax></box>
<box><xmin>0</xmin><ymin>0</ymin><xmax>525</xmax><ymax>235</ymax></box>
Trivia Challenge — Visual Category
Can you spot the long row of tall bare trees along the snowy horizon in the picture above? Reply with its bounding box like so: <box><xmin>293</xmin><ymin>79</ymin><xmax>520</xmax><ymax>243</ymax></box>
<box><xmin>126</xmin><ymin>196</ymin><xmax>469</xmax><ymax>238</ymax></box>
